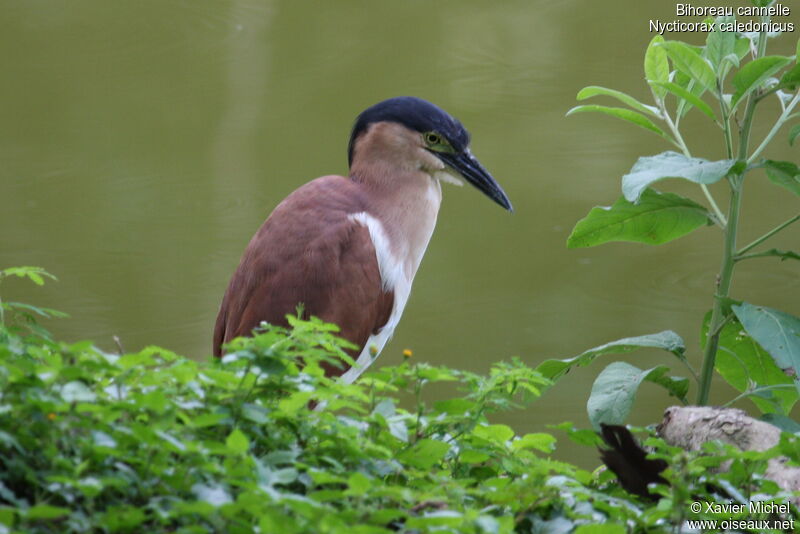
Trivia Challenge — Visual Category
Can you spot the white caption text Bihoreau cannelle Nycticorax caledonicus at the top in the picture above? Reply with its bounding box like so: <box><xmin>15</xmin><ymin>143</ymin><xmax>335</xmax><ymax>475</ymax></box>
<box><xmin>650</xmin><ymin>4</ymin><xmax>795</xmax><ymax>35</ymax></box>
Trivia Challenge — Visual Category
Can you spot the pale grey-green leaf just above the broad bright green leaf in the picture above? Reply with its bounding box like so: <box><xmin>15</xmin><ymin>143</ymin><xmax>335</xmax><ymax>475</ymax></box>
<box><xmin>622</xmin><ymin>151</ymin><xmax>736</xmax><ymax>202</ymax></box>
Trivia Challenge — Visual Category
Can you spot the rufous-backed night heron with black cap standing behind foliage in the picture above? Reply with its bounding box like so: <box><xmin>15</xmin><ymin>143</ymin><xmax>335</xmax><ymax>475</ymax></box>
<box><xmin>214</xmin><ymin>97</ymin><xmax>512</xmax><ymax>382</ymax></box>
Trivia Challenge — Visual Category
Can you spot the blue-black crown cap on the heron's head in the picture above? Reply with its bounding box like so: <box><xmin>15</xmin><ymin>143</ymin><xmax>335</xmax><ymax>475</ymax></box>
<box><xmin>347</xmin><ymin>96</ymin><xmax>469</xmax><ymax>165</ymax></box>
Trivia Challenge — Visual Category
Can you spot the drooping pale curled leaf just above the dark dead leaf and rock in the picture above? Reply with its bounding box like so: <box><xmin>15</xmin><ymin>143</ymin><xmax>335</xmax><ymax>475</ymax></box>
<box><xmin>586</xmin><ymin>362</ymin><xmax>689</xmax><ymax>429</ymax></box>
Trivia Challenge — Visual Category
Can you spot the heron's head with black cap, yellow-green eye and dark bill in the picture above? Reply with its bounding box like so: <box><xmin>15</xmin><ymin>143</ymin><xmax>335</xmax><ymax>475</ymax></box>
<box><xmin>347</xmin><ymin>96</ymin><xmax>513</xmax><ymax>211</ymax></box>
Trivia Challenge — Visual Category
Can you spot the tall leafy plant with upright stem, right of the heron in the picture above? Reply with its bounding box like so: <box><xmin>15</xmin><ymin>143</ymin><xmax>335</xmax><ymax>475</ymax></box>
<box><xmin>556</xmin><ymin>2</ymin><xmax>800</xmax><ymax>432</ymax></box>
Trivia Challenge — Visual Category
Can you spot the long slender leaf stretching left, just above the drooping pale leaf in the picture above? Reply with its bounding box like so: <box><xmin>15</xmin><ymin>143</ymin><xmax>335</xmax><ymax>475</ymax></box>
<box><xmin>536</xmin><ymin>330</ymin><xmax>686</xmax><ymax>380</ymax></box>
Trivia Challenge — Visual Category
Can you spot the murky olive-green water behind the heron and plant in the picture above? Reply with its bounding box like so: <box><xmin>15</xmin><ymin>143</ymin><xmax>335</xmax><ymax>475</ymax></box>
<box><xmin>0</xmin><ymin>0</ymin><xmax>800</xmax><ymax>460</ymax></box>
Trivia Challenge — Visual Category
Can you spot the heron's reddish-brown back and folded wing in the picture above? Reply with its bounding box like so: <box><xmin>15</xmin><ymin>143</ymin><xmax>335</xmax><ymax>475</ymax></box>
<box><xmin>214</xmin><ymin>176</ymin><xmax>393</xmax><ymax>374</ymax></box>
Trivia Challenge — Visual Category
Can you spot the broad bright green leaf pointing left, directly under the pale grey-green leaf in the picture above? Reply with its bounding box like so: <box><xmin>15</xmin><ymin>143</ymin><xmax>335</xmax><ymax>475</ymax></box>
<box><xmin>567</xmin><ymin>189</ymin><xmax>711</xmax><ymax>248</ymax></box>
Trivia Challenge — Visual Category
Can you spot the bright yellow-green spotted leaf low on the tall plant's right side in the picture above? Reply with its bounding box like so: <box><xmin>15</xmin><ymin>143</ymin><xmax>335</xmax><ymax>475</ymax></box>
<box><xmin>700</xmin><ymin>312</ymin><xmax>798</xmax><ymax>413</ymax></box>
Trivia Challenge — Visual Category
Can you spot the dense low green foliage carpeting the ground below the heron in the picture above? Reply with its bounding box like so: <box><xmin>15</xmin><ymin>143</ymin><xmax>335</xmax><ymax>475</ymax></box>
<box><xmin>0</xmin><ymin>270</ymin><xmax>800</xmax><ymax>534</ymax></box>
